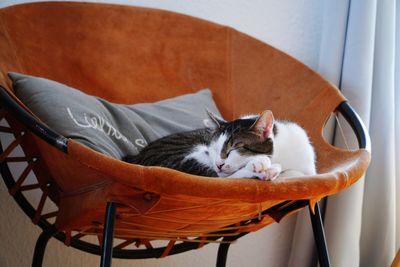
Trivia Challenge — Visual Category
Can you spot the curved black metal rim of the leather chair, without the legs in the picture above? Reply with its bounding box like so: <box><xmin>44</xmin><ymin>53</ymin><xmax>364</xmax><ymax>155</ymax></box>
<box><xmin>0</xmin><ymin>86</ymin><xmax>370</xmax><ymax>259</ymax></box>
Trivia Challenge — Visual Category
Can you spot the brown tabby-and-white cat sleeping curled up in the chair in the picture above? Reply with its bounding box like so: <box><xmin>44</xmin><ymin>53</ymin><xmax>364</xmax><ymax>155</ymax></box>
<box><xmin>124</xmin><ymin>110</ymin><xmax>315</xmax><ymax>180</ymax></box>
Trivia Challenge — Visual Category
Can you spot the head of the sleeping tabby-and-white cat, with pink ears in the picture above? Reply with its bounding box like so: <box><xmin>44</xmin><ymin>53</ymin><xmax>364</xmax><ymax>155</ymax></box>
<box><xmin>204</xmin><ymin>110</ymin><xmax>274</xmax><ymax>177</ymax></box>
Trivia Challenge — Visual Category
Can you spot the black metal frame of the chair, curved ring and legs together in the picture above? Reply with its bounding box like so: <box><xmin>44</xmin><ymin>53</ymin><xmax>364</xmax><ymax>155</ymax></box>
<box><xmin>0</xmin><ymin>86</ymin><xmax>370</xmax><ymax>267</ymax></box>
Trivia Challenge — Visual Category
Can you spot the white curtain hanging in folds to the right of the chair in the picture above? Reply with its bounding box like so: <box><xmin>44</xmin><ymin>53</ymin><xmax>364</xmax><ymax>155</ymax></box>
<box><xmin>302</xmin><ymin>0</ymin><xmax>400</xmax><ymax>267</ymax></box>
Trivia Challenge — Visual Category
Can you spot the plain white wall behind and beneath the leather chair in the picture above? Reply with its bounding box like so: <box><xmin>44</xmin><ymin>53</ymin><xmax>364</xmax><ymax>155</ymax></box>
<box><xmin>0</xmin><ymin>0</ymin><xmax>324</xmax><ymax>267</ymax></box>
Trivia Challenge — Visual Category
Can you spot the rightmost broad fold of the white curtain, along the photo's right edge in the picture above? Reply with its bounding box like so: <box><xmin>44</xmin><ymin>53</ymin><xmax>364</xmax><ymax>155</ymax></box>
<box><xmin>360</xmin><ymin>0</ymin><xmax>400</xmax><ymax>266</ymax></box>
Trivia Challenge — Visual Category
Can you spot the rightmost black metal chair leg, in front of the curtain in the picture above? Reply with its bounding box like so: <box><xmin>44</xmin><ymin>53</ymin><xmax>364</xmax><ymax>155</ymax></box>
<box><xmin>309</xmin><ymin>203</ymin><xmax>330</xmax><ymax>267</ymax></box>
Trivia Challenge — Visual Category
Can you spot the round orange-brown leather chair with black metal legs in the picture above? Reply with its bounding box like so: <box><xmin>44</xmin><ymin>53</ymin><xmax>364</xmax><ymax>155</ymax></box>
<box><xmin>0</xmin><ymin>2</ymin><xmax>370</xmax><ymax>266</ymax></box>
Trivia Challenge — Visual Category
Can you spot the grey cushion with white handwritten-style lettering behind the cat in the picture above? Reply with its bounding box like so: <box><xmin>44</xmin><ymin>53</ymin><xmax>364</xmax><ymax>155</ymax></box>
<box><xmin>9</xmin><ymin>72</ymin><xmax>220</xmax><ymax>159</ymax></box>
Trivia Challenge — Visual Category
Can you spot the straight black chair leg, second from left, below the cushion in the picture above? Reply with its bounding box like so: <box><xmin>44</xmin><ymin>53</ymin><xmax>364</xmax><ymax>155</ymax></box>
<box><xmin>100</xmin><ymin>202</ymin><xmax>117</xmax><ymax>267</ymax></box>
